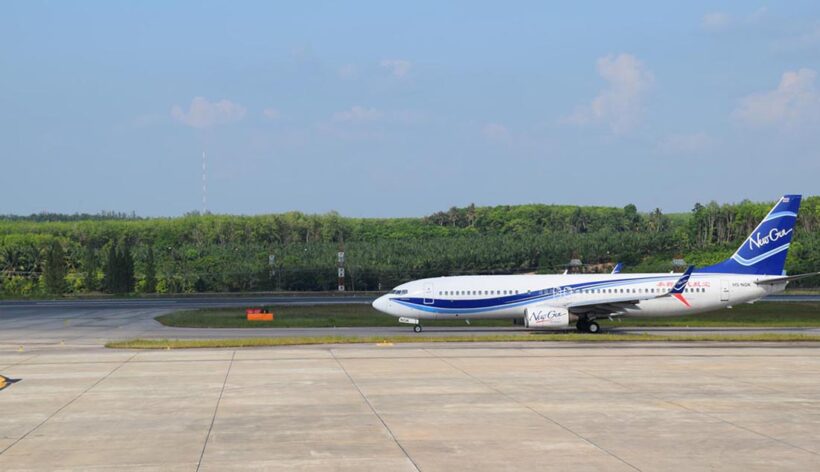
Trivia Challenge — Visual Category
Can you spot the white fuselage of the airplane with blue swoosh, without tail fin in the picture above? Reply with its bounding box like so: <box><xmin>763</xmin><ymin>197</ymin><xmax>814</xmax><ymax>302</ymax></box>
<box><xmin>373</xmin><ymin>272</ymin><xmax>786</xmax><ymax>320</ymax></box>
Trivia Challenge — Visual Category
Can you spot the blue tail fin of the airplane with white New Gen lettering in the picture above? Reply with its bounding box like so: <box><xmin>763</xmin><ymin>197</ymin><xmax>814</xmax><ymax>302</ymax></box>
<box><xmin>697</xmin><ymin>195</ymin><xmax>802</xmax><ymax>275</ymax></box>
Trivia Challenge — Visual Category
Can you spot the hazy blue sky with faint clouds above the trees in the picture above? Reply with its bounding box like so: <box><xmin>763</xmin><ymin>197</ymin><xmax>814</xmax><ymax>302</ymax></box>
<box><xmin>0</xmin><ymin>1</ymin><xmax>820</xmax><ymax>216</ymax></box>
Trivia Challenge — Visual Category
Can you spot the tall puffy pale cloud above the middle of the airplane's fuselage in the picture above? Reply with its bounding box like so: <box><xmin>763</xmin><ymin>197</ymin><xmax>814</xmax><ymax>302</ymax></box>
<box><xmin>566</xmin><ymin>53</ymin><xmax>655</xmax><ymax>133</ymax></box>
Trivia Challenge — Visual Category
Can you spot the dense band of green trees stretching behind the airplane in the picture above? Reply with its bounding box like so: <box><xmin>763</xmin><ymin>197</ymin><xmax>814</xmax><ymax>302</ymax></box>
<box><xmin>0</xmin><ymin>197</ymin><xmax>820</xmax><ymax>297</ymax></box>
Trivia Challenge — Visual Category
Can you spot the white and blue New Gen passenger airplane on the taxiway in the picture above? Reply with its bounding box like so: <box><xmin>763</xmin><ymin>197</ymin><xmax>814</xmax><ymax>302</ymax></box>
<box><xmin>373</xmin><ymin>195</ymin><xmax>820</xmax><ymax>333</ymax></box>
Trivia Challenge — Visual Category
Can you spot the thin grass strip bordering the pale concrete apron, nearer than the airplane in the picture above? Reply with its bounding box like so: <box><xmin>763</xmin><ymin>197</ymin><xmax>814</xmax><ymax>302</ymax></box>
<box><xmin>105</xmin><ymin>333</ymin><xmax>820</xmax><ymax>349</ymax></box>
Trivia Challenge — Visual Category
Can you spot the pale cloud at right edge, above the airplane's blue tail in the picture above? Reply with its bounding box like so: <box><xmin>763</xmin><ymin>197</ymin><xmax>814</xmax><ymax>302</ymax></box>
<box><xmin>733</xmin><ymin>69</ymin><xmax>820</xmax><ymax>127</ymax></box>
